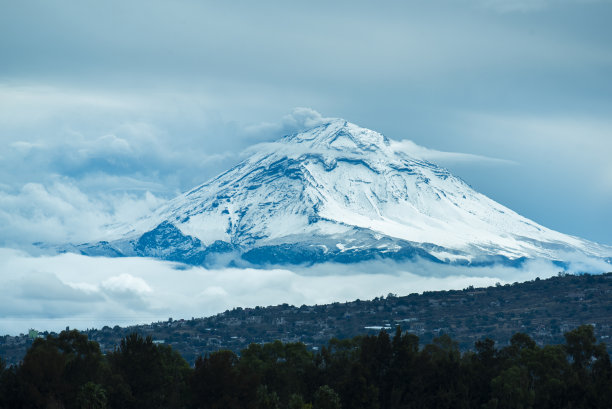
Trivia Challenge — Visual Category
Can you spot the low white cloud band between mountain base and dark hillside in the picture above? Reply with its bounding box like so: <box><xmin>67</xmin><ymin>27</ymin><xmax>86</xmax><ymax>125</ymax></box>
<box><xmin>0</xmin><ymin>248</ymin><xmax>609</xmax><ymax>334</ymax></box>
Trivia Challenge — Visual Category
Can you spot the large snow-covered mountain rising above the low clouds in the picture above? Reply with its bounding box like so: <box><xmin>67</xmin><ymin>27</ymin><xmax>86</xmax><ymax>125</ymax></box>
<box><xmin>75</xmin><ymin>119</ymin><xmax>612</xmax><ymax>265</ymax></box>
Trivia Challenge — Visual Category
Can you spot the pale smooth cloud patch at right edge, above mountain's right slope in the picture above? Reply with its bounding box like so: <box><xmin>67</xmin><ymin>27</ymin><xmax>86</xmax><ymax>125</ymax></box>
<box><xmin>461</xmin><ymin>113</ymin><xmax>612</xmax><ymax>194</ymax></box>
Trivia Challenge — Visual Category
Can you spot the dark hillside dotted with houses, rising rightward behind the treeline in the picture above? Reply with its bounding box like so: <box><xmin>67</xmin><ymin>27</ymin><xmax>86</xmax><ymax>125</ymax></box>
<box><xmin>0</xmin><ymin>273</ymin><xmax>612</xmax><ymax>363</ymax></box>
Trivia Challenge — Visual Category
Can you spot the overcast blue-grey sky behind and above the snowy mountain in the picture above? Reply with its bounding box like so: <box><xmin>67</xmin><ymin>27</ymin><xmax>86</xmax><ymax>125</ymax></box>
<box><xmin>0</xmin><ymin>0</ymin><xmax>612</xmax><ymax>332</ymax></box>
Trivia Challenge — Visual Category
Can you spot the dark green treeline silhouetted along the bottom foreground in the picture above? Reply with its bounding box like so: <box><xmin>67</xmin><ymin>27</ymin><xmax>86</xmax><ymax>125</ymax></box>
<box><xmin>0</xmin><ymin>326</ymin><xmax>612</xmax><ymax>409</ymax></box>
